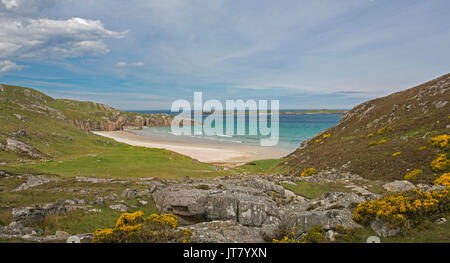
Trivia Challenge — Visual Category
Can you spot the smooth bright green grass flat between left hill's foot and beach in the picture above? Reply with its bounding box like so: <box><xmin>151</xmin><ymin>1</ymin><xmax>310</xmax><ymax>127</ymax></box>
<box><xmin>0</xmin><ymin>145</ymin><xmax>229</xmax><ymax>179</ymax></box>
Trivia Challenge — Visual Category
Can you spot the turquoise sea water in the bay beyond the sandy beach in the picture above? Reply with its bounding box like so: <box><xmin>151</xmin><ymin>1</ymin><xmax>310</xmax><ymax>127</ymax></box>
<box><xmin>132</xmin><ymin>111</ymin><xmax>341</xmax><ymax>153</ymax></box>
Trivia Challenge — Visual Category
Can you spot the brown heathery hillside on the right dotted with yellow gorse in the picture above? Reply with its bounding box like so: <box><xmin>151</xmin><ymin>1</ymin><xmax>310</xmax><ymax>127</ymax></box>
<box><xmin>284</xmin><ymin>74</ymin><xmax>450</xmax><ymax>182</ymax></box>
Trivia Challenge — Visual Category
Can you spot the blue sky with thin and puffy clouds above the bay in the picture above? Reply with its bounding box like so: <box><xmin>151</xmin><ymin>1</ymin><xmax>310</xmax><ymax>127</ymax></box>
<box><xmin>0</xmin><ymin>0</ymin><xmax>450</xmax><ymax>110</ymax></box>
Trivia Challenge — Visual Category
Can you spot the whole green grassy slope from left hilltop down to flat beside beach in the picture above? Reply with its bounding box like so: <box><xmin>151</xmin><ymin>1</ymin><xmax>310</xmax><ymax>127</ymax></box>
<box><xmin>0</xmin><ymin>85</ymin><xmax>227</xmax><ymax>178</ymax></box>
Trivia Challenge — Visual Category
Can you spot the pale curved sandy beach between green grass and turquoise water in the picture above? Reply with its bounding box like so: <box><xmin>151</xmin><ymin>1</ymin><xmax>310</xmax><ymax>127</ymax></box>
<box><xmin>92</xmin><ymin>131</ymin><xmax>290</xmax><ymax>164</ymax></box>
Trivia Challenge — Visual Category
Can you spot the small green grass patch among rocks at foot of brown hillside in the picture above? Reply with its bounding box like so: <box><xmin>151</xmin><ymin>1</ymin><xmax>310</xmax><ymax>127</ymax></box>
<box><xmin>282</xmin><ymin>182</ymin><xmax>351</xmax><ymax>198</ymax></box>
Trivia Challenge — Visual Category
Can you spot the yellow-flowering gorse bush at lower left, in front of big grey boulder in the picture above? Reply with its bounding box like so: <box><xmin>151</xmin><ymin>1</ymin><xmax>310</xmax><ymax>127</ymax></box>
<box><xmin>92</xmin><ymin>211</ymin><xmax>192</xmax><ymax>243</ymax></box>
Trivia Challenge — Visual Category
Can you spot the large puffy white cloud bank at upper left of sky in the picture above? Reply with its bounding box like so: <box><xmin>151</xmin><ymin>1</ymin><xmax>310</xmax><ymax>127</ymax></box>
<box><xmin>0</xmin><ymin>16</ymin><xmax>126</xmax><ymax>59</ymax></box>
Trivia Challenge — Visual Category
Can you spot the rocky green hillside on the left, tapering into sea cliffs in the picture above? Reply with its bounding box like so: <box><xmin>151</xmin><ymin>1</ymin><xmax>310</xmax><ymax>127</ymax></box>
<box><xmin>0</xmin><ymin>85</ymin><xmax>171</xmax><ymax>163</ymax></box>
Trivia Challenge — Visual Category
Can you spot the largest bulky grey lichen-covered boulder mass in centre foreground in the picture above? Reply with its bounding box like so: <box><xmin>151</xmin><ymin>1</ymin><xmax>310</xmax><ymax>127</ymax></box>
<box><xmin>153</xmin><ymin>177</ymin><xmax>284</xmax><ymax>226</ymax></box>
